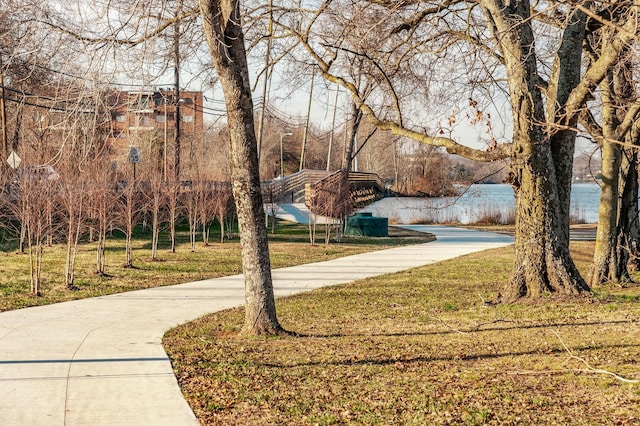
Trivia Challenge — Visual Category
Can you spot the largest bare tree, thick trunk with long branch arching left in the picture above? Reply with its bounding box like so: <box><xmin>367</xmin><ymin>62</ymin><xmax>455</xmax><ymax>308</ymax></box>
<box><xmin>277</xmin><ymin>0</ymin><xmax>637</xmax><ymax>301</ymax></box>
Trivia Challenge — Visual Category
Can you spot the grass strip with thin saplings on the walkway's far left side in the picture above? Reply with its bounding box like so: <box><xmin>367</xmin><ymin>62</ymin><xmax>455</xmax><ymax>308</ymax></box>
<box><xmin>0</xmin><ymin>222</ymin><xmax>427</xmax><ymax>311</ymax></box>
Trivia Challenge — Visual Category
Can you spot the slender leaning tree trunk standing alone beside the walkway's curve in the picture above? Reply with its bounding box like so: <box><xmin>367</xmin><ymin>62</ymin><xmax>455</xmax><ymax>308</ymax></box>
<box><xmin>200</xmin><ymin>0</ymin><xmax>284</xmax><ymax>335</ymax></box>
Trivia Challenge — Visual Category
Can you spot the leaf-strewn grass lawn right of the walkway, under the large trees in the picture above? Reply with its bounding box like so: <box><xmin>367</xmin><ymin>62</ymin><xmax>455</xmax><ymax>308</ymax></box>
<box><xmin>164</xmin><ymin>242</ymin><xmax>640</xmax><ymax>425</ymax></box>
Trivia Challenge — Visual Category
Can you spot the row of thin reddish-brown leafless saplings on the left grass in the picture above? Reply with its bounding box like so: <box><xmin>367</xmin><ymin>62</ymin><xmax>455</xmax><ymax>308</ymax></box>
<box><xmin>0</xmin><ymin>160</ymin><xmax>235</xmax><ymax>296</ymax></box>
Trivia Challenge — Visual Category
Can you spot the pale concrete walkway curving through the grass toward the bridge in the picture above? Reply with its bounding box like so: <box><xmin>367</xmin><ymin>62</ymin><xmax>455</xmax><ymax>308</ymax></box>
<box><xmin>0</xmin><ymin>226</ymin><xmax>512</xmax><ymax>426</ymax></box>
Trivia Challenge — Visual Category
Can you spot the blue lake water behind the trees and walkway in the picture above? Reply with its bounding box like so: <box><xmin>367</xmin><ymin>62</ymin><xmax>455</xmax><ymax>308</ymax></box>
<box><xmin>361</xmin><ymin>183</ymin><xmax>600</xmax><ymax>224</ymax></box>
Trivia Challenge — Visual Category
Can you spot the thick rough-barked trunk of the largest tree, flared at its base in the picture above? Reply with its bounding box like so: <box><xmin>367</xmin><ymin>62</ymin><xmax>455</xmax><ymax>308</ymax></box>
<box><xmin>484</xmin><ymin>0</ymin><xmax>588</xmax><ymax>302</ymax></box>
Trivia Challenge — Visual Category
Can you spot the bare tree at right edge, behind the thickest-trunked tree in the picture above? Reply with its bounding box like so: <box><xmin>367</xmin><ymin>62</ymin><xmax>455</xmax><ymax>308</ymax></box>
<box><xmin>583</xmin><ymin>29</ymin><xmax>640</xmax><ymax>286</ymax></box>
